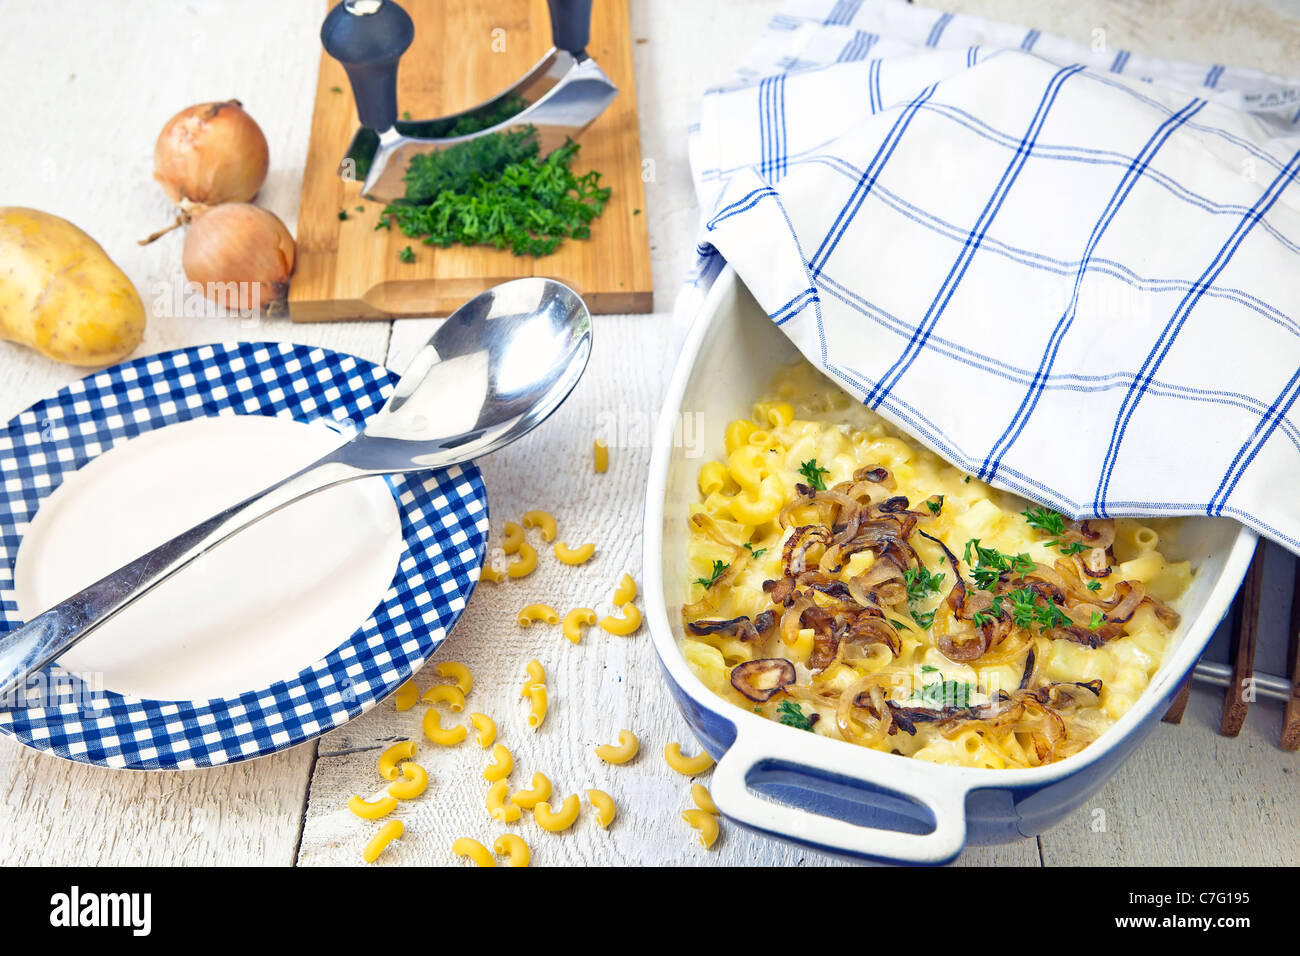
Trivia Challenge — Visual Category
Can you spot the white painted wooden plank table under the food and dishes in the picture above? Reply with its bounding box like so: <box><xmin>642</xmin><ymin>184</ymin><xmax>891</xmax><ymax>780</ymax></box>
<box><xmin>0</xmin><ymin>0</ymin><xmax>1300</xmax><ymax>865</ymax></box>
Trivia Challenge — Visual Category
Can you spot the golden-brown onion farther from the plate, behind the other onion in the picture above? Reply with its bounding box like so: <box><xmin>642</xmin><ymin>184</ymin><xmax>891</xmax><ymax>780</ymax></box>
<box><xmin>153</xmin><ymin>100</ymin><xmax>270</xmax><ymax>211</ymax></box>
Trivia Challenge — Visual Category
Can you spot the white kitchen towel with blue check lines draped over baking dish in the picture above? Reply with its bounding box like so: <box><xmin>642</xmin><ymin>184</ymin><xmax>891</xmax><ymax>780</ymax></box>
<box><xmin>686</xmin><ymin>0</ymin><xmax>1300</xmax><ymax>551</ymax></box>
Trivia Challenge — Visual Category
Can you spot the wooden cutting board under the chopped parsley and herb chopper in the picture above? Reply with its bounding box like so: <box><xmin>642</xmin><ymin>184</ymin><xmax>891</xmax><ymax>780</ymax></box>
<box><xmin>289</xmin><ymin>0</ymin><xmax>653</xmax><ymax>321</ymax></box>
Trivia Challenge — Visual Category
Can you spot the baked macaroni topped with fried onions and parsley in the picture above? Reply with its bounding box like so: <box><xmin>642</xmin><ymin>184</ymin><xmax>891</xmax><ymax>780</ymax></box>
<box><xmin>683</xmin><ymin>362</ymin><xmax>1192</xmax><ymax>769</ymax></box>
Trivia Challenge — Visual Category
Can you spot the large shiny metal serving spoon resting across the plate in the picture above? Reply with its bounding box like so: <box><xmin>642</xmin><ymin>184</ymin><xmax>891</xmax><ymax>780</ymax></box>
<box><xmin>0</xmin><ymin>278</ymin><xmax>592</xmax><ymax>698</ymax></box>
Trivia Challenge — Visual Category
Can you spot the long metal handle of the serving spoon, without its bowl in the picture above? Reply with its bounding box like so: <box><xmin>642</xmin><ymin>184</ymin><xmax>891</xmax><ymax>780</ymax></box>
<box><xmin>0</xmin><ymin>454</ymin><xmax>373</xmax><ymax>706</ymax></box>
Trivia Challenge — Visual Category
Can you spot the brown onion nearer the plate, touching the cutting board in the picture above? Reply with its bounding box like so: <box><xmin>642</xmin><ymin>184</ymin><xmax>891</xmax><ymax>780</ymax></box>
<box><xmin>182</xmin><ymin>203</ymin><xmax>294</xmax><ymax>313</ymax></box>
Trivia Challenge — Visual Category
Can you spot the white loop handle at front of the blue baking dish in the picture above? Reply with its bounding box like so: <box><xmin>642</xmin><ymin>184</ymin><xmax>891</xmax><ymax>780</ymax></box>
<box><xmin>711</xmin><ymin>728</ymin><xmax>967</xmax><ymax>864</ymax></box>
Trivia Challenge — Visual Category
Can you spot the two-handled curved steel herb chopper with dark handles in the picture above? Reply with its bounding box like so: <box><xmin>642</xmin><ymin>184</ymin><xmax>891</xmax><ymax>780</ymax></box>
<box><xmin>321</xmin><ymin>0</ymin><xmax>619</xmax><ymax>202</ymax></box>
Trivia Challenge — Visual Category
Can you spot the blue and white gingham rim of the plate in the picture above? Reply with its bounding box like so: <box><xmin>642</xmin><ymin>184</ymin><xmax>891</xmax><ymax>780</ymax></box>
<box><xmin>0</xmin><ymin>342</ymin><xmax>488</xmax><ymax>770</ymax></box>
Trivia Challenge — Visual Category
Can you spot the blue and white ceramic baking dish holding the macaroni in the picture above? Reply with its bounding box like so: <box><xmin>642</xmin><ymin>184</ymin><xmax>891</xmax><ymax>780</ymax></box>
<box><xmin>644</xmin><ymin>267</ymin><xmax>1256</xmax><ymax>864</ymax></box>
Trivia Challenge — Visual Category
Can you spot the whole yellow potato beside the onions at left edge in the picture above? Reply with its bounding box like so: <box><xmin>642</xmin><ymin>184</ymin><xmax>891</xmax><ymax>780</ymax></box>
<box><xmin>0</xmin><ymin>206</ymin><xmax>144</xmax><ymax>365</ymax></box>
